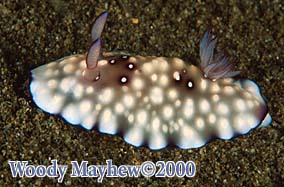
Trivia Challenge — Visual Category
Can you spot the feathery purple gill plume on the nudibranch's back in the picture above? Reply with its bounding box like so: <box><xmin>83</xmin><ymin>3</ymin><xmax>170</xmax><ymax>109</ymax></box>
<box><xmin>199</xmin><ymin>31</ymin><xmax>240</xmax><ymax>79</ymax></box>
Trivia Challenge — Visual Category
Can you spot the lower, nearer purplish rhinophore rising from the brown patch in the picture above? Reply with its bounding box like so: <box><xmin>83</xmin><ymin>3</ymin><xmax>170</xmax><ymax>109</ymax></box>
<box><xmin>86</xmin><ymin>39</ymin><xmax>102</xmax><ymax>69</ymax></box>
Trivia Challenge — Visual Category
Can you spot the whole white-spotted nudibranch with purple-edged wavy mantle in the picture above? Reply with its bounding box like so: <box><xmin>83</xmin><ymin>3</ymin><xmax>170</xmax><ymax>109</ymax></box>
<box><xmin>30</xmin><ymin>12</ymin><xmax>272</xmax><ymax>150</ymax></box>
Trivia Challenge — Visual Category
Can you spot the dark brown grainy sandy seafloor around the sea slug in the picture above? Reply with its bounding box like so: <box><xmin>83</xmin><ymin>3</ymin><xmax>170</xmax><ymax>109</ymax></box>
<box><xmin>0</xmin><ymin>0</ymin><xmax>284</xmax><ymax>186</ymax></box>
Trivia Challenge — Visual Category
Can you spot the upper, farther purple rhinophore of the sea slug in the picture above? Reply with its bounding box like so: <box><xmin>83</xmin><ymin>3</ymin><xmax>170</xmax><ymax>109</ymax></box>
<box><xmin>91</xmin><ymin>12</ymin><xmax>108</xmax><ymax>41</ymax></box>
